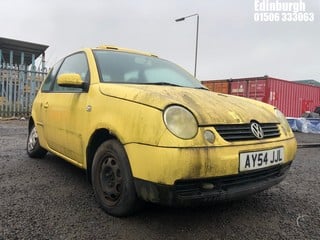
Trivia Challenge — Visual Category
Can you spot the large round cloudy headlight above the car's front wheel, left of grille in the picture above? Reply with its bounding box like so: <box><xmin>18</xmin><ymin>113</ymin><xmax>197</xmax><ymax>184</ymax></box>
<box><xmin>163</xmin><ymin>105</ymin><xmax>198</xmax><ymax>139</ymax></box>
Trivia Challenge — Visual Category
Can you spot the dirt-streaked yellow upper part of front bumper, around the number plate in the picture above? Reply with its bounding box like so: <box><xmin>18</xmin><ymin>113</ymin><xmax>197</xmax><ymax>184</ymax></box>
<box><xmin>125</xmin><ymin>137</ymin><xmax>297</xmax><ymax>186</ymax></box>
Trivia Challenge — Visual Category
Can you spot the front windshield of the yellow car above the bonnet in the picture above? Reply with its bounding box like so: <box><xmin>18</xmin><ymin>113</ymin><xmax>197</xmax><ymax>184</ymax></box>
<box><xmin>94</xmin><ymin>50</ymin><xmax>204</xmax><ymax>88</ymax></box>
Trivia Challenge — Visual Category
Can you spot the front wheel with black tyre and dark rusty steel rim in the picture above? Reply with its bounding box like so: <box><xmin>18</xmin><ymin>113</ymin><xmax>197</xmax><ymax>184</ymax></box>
<box><xmin>91</xmin><ymin>139</ymin><xmax>140</xmax><ymax>217</ymax></box>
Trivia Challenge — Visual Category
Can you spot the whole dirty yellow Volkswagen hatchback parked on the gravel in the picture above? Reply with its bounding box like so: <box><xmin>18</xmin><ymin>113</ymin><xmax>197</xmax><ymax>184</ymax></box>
<box><xmin>27</xmin><ymin>46</ymin><xmax>297</xmax><ymax>216</ymax></box>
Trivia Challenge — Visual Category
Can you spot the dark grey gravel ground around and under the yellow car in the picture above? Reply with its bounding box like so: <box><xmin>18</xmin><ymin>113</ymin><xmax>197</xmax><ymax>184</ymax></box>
<box><xmin>0</xmin><ymin>121</ymin><xmax>320</xmax><ymax>240</ymax></box>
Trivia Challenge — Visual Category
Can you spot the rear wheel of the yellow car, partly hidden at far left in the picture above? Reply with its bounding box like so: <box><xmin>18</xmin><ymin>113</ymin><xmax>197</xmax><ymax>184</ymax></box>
<box><xmin>27</xmin><ymin>125</ymin><xmax>47</xmax><ymax>158</ymax></box>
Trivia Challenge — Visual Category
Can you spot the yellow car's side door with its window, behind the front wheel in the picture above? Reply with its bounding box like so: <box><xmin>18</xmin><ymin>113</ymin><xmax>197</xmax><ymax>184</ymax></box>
<box><xmin>44</xmin><ymin>52</ymin><xmax>90</xmax><ymax>165</ymax></box>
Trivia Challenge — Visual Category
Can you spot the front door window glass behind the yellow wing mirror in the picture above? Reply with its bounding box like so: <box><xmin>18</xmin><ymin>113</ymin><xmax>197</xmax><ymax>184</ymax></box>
<box><xmin>53</xmin><ymin>52</ymin><xmax>90</xmax><ymax>92</ymax></box>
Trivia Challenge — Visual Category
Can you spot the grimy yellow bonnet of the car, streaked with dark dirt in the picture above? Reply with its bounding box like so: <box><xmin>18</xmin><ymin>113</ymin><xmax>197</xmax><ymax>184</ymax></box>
<box><xmin>100</xmin><ymin>83</ymin><xmax>278</xmax><ymax>125</ymax></box>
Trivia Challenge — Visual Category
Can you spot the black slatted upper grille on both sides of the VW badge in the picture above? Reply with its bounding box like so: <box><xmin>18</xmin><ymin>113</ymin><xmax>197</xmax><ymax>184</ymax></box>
<box><xmin>213</xmin><ymin>123</ymin><xmax>280</xmax><ymax>142</ymax></box>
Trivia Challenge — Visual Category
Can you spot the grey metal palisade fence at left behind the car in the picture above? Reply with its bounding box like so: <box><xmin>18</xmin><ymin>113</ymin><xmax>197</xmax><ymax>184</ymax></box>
<box><xmin>0</xmin><ymin>63</ymin><xmax>47</xmax><ymax>118</ymax></box>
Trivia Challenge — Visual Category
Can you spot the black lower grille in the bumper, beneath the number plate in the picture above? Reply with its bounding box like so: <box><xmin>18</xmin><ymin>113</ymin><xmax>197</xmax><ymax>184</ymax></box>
<box><xmin>174</xmin><ymin>163</ymin><xmax>291</xmax><ymax>199</ymax></box>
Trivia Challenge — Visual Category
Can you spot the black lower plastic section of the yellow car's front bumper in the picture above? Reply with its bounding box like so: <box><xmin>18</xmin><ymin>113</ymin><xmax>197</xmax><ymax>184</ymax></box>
<box><xmin>135</xmin><ymin>162</ymin><xmax>291</xmax><ymax>206</ymax></box>
